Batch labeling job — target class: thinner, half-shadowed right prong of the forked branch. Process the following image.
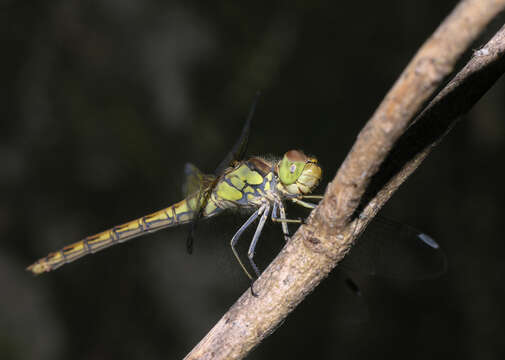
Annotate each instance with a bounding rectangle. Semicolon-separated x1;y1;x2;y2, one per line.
356;25;505;225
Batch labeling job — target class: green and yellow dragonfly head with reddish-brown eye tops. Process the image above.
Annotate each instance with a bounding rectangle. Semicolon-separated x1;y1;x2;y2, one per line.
277;150;322;194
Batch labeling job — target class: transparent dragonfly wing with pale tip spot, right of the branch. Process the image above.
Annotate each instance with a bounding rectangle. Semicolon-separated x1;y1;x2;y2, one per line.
342;217;447;280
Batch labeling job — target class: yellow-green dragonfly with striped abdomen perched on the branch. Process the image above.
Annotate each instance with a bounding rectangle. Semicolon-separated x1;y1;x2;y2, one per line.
27;94;439;294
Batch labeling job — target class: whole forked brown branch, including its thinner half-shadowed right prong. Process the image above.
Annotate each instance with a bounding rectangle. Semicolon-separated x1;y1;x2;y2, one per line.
186;0;505;359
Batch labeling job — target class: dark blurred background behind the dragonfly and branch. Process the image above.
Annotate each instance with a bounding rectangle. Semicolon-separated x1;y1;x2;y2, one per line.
0;0;505;360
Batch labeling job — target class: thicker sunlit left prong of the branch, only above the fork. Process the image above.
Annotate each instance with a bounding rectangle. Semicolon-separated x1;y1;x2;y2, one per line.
320;0;504;231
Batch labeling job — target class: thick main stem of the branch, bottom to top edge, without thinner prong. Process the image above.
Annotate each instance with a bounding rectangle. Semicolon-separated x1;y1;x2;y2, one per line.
186;0;505;359
